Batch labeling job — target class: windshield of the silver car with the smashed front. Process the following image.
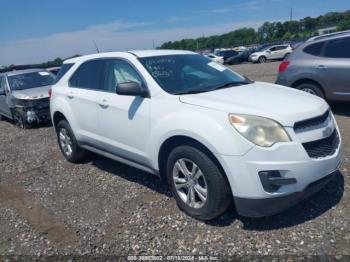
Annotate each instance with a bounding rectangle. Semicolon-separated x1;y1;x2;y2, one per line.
8;71;55;90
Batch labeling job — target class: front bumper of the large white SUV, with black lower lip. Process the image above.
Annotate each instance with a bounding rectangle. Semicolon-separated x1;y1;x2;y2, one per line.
220;129;342;217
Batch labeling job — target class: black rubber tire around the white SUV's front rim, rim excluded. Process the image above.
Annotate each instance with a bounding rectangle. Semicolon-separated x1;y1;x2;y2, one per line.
166;145;232;220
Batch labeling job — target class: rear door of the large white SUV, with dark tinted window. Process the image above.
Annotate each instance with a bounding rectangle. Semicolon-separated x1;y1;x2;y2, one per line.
67;60;104;146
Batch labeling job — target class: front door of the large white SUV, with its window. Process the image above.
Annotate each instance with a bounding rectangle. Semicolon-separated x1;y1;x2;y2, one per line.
98;58;151;165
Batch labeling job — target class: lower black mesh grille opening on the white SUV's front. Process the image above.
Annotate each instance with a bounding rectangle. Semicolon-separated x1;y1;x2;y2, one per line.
303;129;339;158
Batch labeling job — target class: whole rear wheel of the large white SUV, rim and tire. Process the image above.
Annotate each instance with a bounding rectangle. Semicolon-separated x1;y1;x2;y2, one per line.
56;120;86;163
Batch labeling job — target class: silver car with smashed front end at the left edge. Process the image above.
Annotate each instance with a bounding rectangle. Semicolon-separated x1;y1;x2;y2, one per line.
0;69;55;129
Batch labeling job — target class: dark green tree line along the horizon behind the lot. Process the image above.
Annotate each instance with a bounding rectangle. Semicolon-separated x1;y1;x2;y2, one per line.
159;10;350;51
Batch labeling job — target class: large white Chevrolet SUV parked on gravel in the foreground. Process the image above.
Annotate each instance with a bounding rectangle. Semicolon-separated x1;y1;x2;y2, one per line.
51;50;341;220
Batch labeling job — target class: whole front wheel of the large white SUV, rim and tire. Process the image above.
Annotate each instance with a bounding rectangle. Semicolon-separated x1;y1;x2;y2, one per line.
167;145;232;220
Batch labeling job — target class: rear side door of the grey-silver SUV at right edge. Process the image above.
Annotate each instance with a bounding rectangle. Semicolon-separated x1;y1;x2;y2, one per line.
315;37;350;98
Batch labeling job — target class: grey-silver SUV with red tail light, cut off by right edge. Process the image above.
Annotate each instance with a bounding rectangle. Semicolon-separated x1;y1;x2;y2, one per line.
276;31;350;101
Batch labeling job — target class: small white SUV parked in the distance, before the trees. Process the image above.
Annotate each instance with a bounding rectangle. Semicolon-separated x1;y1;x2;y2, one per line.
249;45;293;64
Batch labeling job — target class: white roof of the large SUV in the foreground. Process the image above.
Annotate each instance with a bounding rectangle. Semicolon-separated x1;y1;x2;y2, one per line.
64;49;198;64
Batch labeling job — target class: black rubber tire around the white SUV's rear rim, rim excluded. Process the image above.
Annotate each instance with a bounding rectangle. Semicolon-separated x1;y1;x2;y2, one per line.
56;120;86;163
